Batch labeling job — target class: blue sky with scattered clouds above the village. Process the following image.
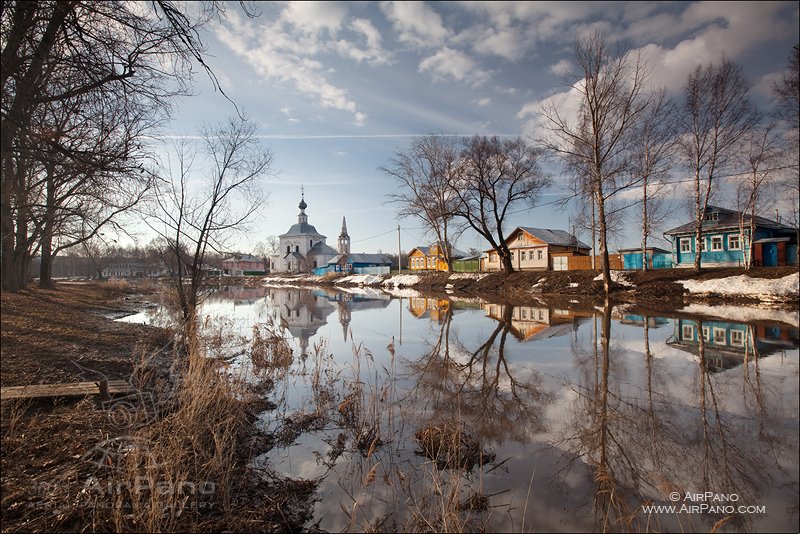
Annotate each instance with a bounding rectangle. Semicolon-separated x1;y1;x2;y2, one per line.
145;1;800;253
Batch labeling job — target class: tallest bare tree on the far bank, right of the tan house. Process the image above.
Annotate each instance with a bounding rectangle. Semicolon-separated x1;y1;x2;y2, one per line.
539;33;653;293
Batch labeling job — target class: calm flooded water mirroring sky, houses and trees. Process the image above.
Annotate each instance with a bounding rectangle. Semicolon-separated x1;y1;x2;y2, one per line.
119;288;800;532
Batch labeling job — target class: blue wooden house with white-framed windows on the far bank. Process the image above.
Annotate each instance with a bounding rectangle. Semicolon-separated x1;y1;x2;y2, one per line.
664;206;797;267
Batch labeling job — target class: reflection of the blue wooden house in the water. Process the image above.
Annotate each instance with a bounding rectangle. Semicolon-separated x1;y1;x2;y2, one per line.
667;319;798;373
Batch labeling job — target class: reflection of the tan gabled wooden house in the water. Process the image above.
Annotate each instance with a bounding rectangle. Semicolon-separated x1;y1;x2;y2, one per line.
483;304;592;341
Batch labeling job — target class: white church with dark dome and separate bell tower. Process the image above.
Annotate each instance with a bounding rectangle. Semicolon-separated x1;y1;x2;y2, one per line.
270;195;350;273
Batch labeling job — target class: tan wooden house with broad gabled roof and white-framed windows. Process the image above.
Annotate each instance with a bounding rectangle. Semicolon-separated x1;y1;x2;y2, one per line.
481;226;591;272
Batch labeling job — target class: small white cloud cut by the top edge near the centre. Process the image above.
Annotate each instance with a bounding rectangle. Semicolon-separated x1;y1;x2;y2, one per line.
381;2;450;46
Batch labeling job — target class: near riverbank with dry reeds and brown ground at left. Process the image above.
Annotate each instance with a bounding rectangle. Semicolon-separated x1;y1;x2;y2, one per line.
0;282;315;532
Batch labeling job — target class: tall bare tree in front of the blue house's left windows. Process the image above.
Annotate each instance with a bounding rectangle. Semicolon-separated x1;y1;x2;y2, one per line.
680;58;759;271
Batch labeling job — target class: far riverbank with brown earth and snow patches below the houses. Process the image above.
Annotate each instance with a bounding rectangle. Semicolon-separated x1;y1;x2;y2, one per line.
261;266;800;309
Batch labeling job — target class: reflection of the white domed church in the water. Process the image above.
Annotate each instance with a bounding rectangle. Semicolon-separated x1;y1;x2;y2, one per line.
267;288;391;357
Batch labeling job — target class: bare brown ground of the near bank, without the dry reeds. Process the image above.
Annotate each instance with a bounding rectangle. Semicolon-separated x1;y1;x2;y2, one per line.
0;283;315;532
